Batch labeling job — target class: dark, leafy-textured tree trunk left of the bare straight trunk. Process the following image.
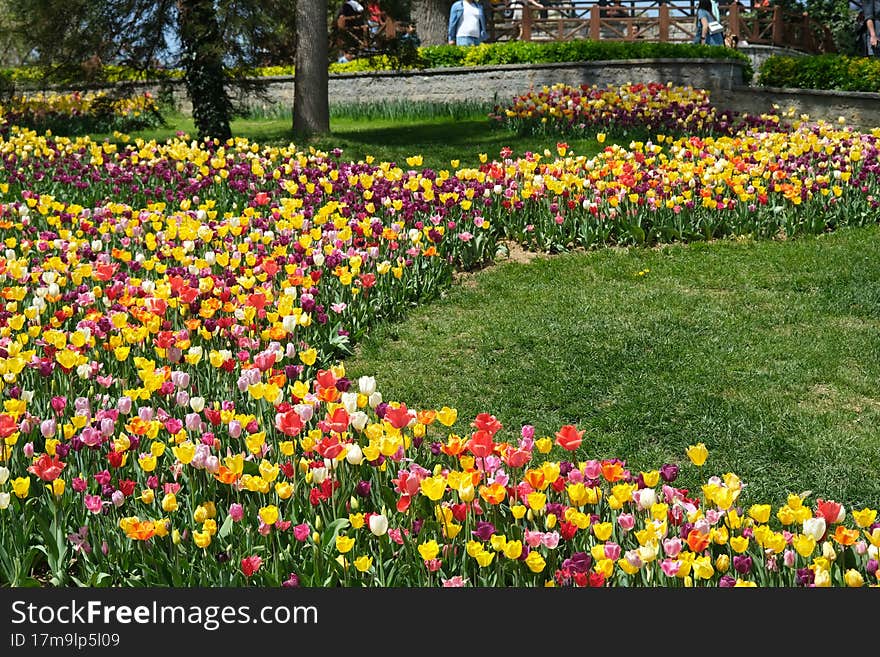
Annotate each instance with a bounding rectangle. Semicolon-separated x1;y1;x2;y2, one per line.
178;0;232;143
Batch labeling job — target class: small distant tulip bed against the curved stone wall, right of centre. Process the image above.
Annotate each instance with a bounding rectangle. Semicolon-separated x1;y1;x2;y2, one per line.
490;82;791;136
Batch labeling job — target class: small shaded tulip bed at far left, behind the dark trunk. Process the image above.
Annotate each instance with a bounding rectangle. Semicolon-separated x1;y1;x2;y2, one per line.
0;91;163;135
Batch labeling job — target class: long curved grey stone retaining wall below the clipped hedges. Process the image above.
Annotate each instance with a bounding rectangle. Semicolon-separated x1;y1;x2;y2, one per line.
44;57;880;130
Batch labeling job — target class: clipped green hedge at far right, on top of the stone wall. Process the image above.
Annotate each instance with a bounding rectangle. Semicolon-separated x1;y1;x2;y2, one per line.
758;55;880;92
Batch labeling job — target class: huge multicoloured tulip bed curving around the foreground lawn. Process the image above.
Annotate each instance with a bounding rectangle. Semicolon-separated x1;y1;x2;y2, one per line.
0;89;880;587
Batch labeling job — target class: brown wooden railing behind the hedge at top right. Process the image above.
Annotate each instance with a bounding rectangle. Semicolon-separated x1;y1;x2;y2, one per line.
490;0;835;53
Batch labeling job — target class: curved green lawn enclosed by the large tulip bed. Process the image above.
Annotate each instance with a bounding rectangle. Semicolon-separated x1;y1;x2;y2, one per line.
346;227;880;508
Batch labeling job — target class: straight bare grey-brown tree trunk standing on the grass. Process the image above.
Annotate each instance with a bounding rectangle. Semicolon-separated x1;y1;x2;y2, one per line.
293;0;330;135
